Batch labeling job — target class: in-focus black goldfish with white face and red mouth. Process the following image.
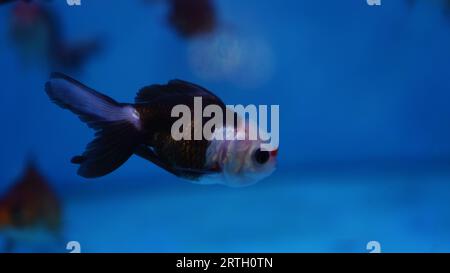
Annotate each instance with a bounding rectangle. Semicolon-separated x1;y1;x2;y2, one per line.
45;73;278;187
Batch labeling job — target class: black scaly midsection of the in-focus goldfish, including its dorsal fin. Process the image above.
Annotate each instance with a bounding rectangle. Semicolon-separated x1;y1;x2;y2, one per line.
134;80;226;178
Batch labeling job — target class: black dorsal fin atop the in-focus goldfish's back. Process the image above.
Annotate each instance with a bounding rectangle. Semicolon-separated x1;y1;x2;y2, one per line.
135;80;222;104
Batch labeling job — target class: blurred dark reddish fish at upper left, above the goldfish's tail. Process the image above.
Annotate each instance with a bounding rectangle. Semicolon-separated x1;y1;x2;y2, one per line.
10;1;101;72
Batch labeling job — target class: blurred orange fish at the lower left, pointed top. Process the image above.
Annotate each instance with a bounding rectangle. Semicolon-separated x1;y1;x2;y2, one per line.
0;161;62;252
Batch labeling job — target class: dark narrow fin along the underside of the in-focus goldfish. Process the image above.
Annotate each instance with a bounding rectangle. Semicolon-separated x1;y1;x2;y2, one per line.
134;145;219;179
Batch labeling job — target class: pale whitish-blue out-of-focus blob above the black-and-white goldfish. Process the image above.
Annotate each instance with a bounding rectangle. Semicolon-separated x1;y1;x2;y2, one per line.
187;28;275;90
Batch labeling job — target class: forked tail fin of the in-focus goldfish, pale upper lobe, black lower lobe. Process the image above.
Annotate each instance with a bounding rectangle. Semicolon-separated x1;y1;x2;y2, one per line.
45;73;141;178
